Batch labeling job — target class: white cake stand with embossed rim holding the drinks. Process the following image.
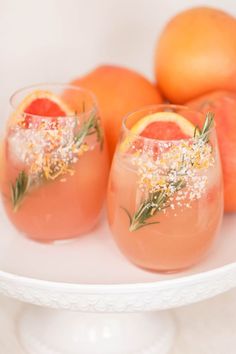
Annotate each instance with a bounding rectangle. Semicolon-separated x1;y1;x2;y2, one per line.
0;204;236;354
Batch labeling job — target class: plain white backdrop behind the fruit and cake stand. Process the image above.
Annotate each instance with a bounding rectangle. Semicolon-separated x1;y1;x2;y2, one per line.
0;0;236;354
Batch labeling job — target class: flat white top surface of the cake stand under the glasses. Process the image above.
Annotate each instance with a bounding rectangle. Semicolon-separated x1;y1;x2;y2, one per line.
0;199;236;284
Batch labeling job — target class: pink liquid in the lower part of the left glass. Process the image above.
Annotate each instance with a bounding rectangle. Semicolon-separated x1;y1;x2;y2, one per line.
1;137;108;242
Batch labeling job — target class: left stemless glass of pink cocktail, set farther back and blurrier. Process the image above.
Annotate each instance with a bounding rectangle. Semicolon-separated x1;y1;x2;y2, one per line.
1;84;108;242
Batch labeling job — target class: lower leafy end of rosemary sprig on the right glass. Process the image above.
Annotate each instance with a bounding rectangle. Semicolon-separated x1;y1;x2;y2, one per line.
122;179;185;232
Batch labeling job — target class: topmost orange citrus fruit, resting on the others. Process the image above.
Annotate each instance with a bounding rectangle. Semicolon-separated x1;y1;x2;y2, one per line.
155;7;236;103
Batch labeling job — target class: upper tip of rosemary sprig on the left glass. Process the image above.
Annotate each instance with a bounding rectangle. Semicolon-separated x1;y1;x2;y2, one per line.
75;114;103;150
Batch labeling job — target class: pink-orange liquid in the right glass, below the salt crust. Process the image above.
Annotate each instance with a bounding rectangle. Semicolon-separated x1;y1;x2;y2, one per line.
107;154;223;272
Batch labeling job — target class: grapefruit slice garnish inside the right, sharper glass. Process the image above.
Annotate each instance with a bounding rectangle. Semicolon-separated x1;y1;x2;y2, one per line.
121;112;195;152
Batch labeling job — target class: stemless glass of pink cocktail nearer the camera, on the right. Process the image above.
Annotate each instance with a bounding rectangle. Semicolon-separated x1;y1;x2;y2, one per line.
107;105;223;272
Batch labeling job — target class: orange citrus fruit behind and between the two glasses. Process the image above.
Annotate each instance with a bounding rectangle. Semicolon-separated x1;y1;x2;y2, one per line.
65;65;162;157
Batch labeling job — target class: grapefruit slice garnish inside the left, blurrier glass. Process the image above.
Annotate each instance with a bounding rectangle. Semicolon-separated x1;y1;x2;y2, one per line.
10;90;74;128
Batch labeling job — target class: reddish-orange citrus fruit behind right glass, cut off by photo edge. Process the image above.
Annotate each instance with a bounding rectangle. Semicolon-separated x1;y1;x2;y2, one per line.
188;91;236;211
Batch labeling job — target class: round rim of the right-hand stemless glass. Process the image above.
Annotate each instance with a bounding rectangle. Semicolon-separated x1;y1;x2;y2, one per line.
122;103;216;144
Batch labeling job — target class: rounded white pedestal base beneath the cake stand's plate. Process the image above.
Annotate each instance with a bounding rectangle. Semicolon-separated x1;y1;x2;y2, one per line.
20;307;175;354
